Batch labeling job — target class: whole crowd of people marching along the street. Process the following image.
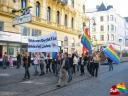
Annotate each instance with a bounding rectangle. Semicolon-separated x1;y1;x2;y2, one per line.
0;51;113;87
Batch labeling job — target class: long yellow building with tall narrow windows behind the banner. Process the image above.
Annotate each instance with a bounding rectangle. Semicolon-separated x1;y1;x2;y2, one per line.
0;0;86;58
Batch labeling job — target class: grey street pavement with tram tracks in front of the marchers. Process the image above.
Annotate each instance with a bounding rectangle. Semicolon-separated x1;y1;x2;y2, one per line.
0;62;128;96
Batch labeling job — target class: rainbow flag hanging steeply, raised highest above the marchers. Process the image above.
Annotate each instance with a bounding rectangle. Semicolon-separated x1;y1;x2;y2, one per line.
81;28;92;54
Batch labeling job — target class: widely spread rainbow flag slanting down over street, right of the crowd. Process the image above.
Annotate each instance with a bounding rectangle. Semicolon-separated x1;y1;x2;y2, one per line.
103;45;120;64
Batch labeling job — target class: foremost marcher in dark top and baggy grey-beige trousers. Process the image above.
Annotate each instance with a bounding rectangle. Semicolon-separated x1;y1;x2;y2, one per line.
57;53;69;87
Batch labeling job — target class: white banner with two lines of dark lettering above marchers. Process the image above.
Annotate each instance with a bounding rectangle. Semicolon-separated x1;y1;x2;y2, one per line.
28;32;58;52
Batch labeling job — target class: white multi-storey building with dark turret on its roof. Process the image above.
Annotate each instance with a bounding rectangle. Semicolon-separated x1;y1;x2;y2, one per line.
87;3;128;51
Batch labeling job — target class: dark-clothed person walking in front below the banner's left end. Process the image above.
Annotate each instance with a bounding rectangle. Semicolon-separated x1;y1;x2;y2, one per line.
23;53;31;80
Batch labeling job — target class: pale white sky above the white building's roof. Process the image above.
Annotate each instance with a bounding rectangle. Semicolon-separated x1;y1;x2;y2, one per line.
86;0;128;17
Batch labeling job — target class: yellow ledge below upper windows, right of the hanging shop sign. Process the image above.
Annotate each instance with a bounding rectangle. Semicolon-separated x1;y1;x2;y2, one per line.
31;16;80;35
